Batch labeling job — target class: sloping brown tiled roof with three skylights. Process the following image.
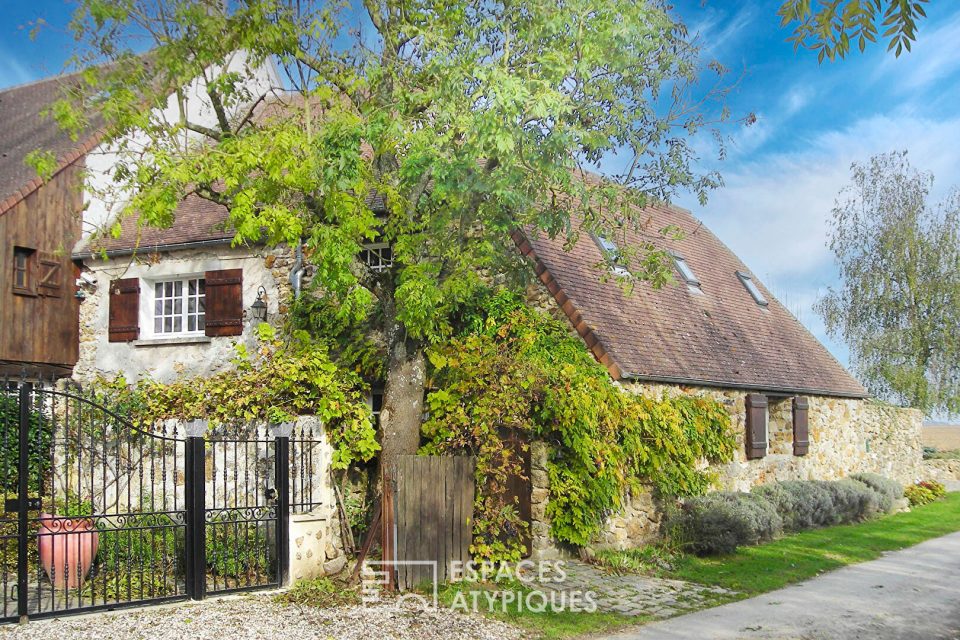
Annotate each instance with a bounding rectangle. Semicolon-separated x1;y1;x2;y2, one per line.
514;206;867;397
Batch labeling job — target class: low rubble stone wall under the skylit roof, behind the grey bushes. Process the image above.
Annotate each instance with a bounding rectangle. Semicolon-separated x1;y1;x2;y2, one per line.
532;383;928;557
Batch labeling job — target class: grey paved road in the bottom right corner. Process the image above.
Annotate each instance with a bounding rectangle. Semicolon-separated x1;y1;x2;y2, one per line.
614;533;960;640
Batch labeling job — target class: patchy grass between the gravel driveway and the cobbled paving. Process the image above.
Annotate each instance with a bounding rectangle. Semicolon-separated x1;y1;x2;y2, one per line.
440;583;650;640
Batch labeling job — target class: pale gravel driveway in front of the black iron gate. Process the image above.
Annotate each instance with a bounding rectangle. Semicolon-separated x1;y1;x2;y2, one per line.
0;594;523;640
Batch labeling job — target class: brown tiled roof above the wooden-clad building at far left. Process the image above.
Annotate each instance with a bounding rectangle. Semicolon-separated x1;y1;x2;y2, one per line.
0;75;96;214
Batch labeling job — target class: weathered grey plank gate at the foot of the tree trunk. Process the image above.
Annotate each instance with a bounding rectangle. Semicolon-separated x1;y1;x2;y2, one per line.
385;456;475;589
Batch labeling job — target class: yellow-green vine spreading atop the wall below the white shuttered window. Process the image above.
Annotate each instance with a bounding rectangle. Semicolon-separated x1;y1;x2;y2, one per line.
99;323;380;468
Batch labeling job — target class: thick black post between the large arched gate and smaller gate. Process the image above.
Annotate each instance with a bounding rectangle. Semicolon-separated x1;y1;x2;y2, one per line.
184;432;207;600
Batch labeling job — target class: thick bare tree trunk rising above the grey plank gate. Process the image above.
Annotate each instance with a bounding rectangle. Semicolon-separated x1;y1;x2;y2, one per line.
380;328;426;469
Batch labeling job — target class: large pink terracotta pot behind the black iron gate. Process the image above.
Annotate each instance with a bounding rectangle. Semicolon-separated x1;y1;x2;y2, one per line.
37;513;100;589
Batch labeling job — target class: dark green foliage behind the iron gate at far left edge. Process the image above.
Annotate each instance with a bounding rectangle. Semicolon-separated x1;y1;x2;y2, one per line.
0;393;53;494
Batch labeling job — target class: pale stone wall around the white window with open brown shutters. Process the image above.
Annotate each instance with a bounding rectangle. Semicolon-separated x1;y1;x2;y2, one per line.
74;245;293;382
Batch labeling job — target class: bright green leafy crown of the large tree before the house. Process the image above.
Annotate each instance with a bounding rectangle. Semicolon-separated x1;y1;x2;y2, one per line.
50;0;729;456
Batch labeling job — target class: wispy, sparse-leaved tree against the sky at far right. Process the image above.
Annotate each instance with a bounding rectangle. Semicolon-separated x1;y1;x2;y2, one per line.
817;152;960;414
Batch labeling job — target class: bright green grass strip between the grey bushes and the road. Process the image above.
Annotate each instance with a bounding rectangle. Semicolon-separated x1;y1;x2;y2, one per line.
663;493;960;598
